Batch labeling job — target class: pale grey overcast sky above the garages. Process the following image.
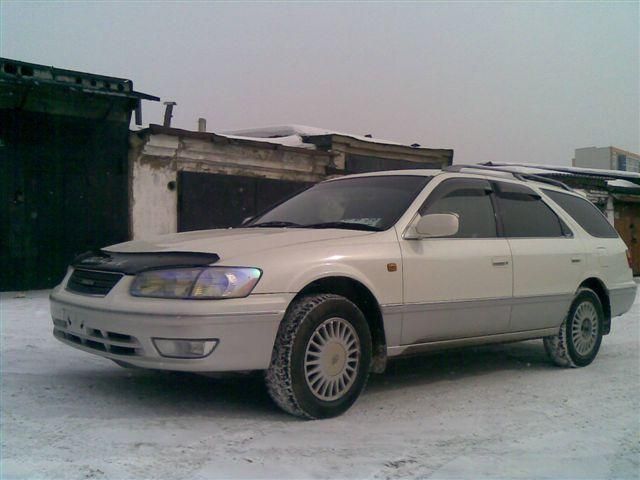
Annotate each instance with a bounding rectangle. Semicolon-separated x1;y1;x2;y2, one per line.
0;0;640;165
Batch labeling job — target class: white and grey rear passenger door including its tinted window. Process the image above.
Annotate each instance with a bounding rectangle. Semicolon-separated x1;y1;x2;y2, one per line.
493;182;585;332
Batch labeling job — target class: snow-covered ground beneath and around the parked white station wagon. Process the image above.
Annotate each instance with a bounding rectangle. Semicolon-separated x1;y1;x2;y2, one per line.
0;291;640;479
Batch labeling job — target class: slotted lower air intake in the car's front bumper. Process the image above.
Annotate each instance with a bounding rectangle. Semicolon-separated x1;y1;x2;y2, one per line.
53;318;143;356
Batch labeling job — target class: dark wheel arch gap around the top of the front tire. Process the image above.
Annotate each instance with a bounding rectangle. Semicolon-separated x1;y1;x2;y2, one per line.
294;276;387;373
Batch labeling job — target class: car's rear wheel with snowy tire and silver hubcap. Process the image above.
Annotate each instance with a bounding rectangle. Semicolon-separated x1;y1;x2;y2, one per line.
543;288;604;367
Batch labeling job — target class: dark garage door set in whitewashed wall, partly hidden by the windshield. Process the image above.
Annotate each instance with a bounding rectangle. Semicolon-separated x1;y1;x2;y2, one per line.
178;172;313;232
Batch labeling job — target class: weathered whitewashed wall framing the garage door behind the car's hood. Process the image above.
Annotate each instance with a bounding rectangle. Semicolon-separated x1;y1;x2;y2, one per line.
129;132;334;239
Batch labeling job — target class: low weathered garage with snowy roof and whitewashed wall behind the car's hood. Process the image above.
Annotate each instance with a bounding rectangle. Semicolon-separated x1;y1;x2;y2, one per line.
129;125;453;239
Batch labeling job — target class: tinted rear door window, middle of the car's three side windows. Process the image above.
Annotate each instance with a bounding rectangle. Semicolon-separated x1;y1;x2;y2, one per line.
496;183;570;238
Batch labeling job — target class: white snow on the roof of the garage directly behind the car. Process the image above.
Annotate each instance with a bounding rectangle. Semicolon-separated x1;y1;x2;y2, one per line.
220;125;426;149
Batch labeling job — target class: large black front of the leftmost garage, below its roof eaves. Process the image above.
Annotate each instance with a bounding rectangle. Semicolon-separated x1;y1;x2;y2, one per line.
0;110;129;290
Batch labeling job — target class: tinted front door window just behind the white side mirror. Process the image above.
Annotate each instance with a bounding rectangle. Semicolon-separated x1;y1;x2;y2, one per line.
420;179;497;238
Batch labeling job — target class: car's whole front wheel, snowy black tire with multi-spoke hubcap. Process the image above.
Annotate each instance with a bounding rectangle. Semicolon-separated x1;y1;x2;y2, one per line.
265;294;372;419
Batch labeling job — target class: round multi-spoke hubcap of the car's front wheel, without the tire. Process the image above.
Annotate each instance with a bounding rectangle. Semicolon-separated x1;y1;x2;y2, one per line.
304;317;360;401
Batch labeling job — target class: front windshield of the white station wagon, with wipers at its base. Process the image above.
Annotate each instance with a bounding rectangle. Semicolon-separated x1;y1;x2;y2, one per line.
247;175;431;231
